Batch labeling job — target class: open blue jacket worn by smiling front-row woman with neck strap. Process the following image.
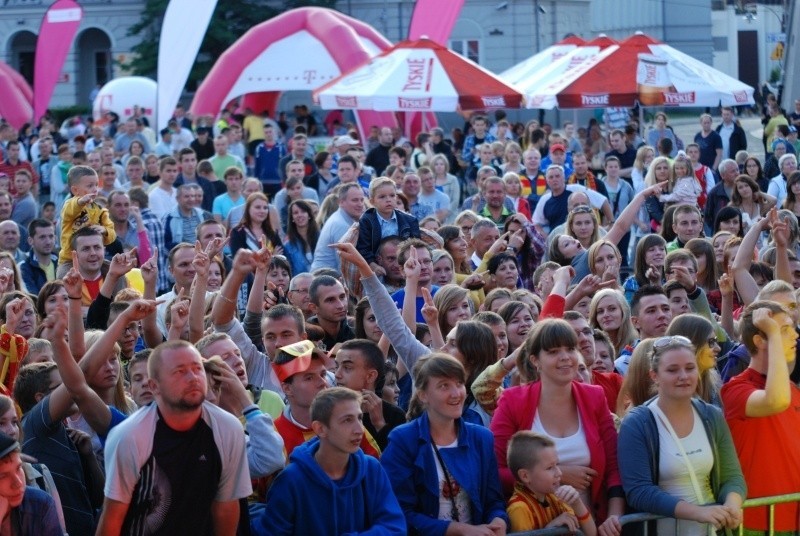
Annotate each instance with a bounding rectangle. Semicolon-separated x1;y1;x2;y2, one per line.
381;413;508;536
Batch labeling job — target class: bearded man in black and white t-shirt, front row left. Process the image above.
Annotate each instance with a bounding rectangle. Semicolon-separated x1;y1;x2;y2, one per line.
97;341;252;535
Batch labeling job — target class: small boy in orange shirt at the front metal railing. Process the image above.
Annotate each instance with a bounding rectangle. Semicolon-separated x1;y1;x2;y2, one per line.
506;430;597;536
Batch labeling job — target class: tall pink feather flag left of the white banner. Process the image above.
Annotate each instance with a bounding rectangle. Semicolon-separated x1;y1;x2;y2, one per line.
33;0;83;122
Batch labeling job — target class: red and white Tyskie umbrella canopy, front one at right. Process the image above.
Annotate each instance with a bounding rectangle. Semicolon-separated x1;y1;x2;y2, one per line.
525;33;754;109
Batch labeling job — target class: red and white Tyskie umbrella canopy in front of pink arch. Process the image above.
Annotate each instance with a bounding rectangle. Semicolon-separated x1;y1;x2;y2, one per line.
314;38;523;112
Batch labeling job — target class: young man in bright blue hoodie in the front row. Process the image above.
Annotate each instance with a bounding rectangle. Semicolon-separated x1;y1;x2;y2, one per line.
255;387;406;536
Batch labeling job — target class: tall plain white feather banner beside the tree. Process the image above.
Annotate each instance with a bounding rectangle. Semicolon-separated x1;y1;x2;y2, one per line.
156;0;217;132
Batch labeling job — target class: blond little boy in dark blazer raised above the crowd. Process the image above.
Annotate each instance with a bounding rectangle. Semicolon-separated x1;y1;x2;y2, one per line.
356;177;420;276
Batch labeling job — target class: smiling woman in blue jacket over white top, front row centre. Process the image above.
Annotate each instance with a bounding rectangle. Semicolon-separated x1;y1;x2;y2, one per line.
381;354;508;536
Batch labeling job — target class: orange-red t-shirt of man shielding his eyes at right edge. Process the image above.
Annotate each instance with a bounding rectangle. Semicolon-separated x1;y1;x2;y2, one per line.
721;368;800;531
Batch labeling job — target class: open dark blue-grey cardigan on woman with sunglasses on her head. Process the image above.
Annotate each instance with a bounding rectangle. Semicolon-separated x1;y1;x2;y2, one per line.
617;398;747;517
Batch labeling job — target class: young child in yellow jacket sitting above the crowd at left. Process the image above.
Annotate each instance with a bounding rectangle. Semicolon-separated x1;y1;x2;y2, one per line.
56;166;117;278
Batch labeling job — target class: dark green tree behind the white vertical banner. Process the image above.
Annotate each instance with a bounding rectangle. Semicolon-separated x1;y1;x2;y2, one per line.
122;0;336;91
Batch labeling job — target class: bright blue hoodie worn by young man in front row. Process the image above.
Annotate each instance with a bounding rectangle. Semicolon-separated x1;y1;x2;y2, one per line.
253;438;406;536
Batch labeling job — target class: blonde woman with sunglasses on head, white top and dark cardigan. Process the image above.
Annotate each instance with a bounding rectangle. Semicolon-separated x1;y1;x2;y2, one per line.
618;336;746;536
